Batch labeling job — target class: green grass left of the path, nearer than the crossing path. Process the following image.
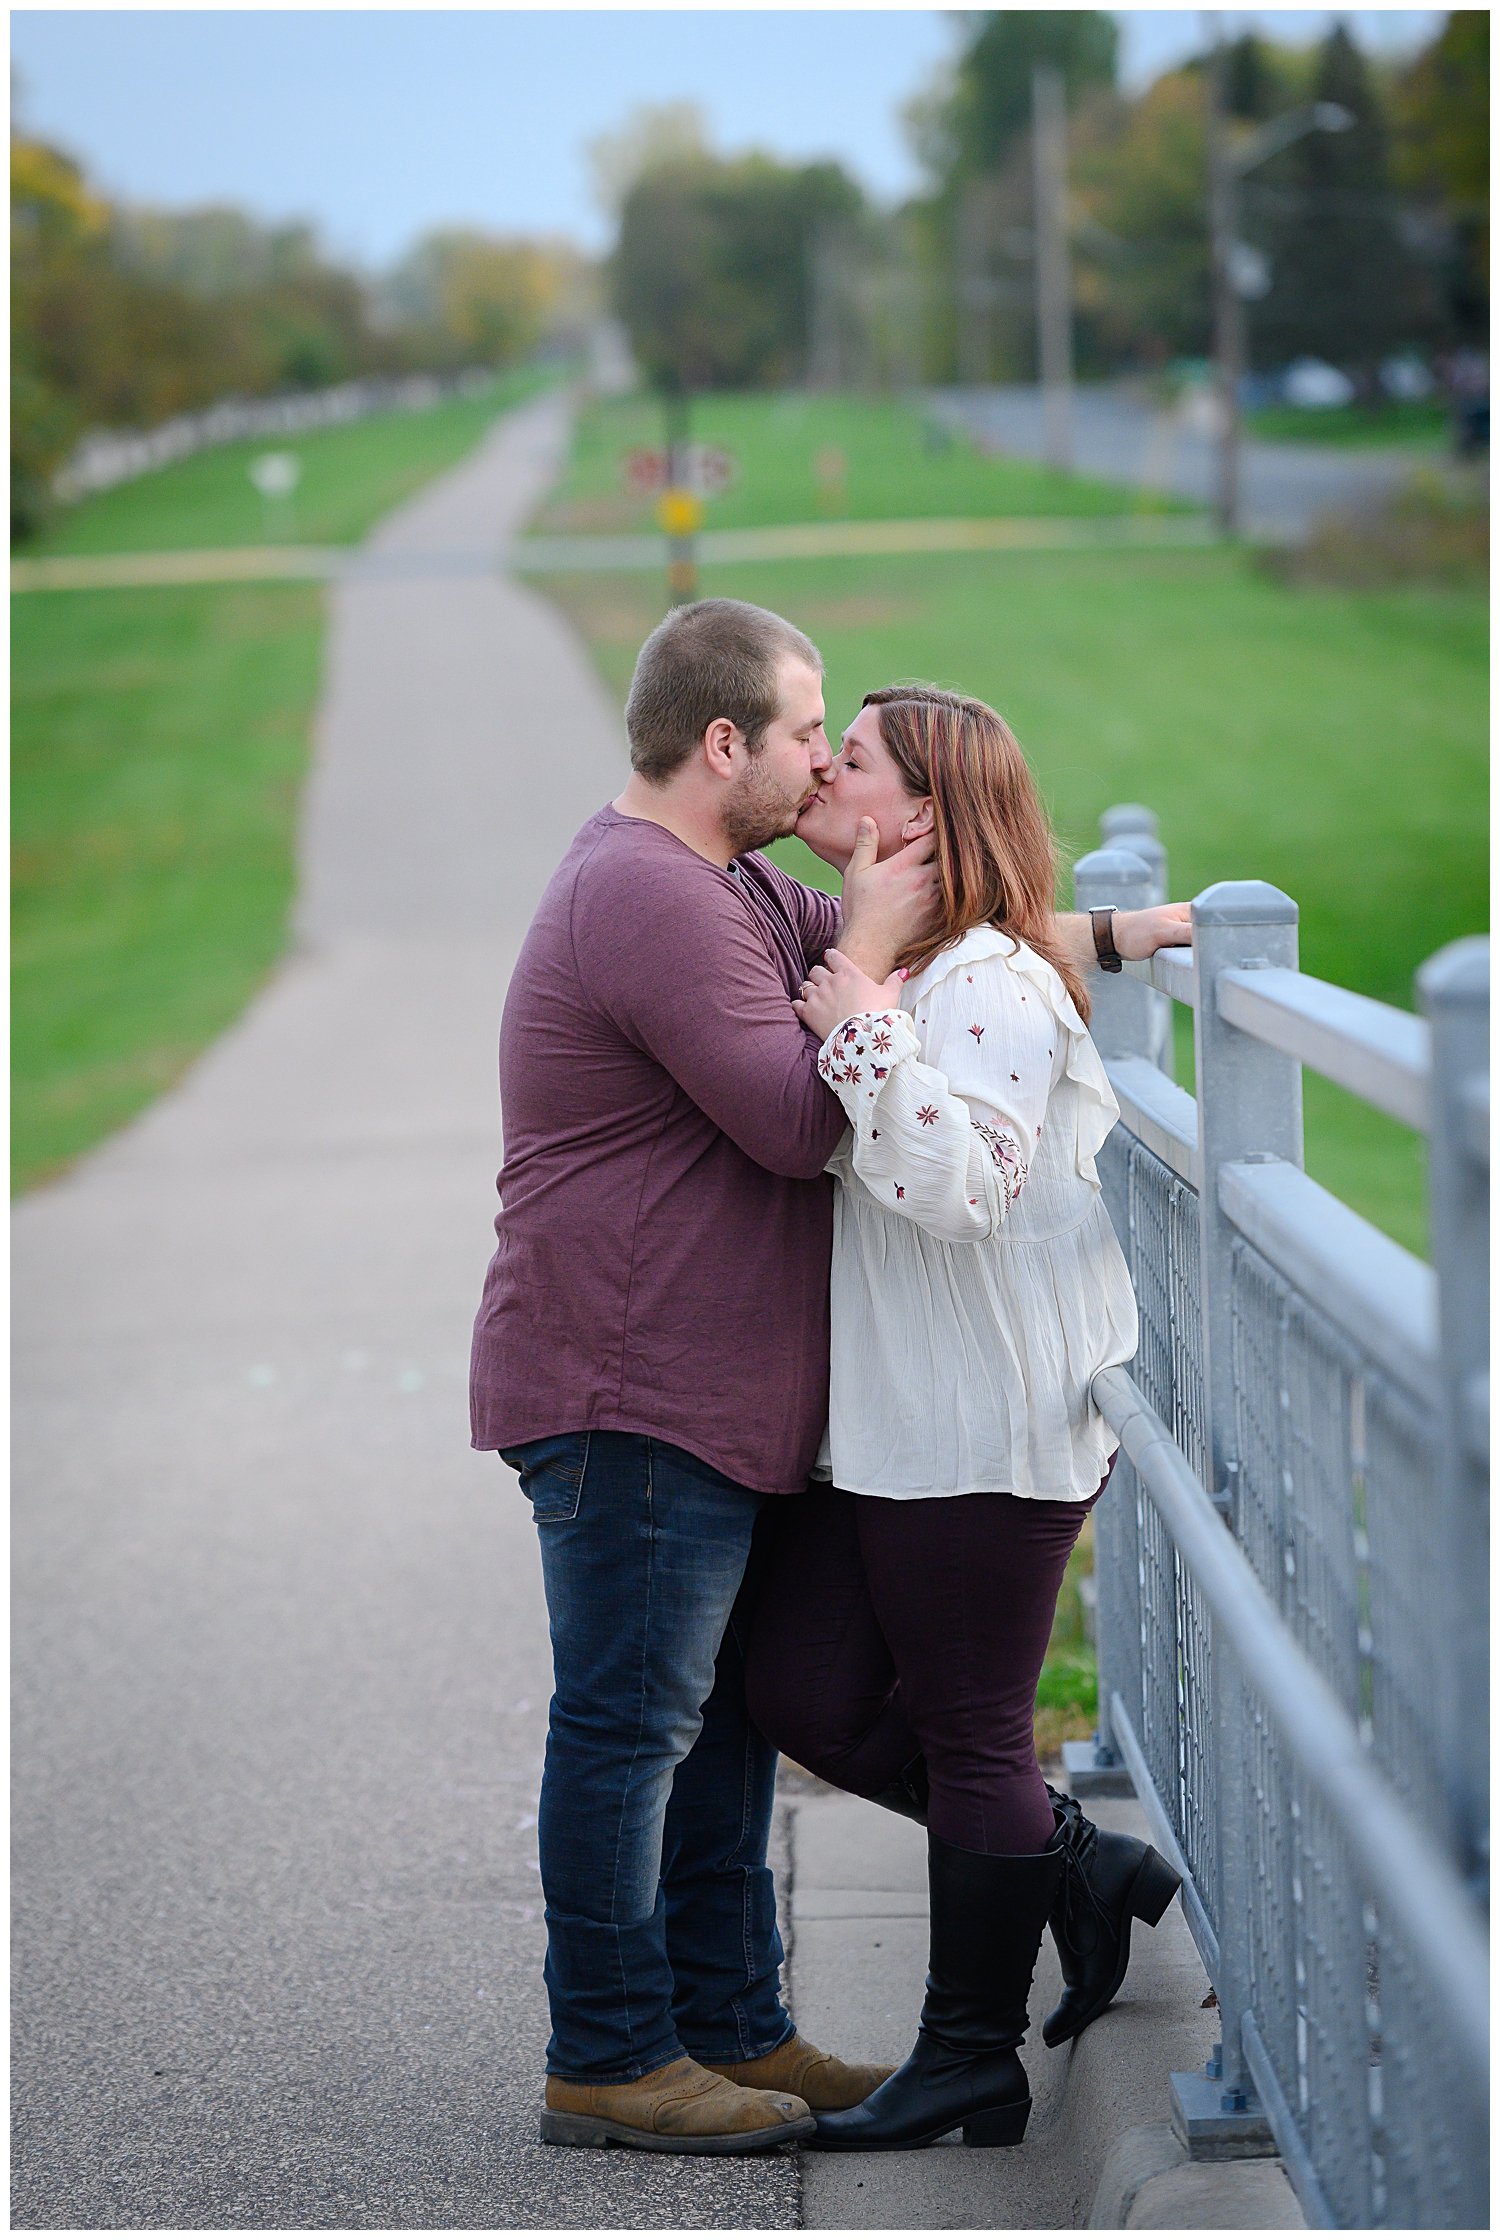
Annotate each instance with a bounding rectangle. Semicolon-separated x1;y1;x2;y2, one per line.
11;587;322;1189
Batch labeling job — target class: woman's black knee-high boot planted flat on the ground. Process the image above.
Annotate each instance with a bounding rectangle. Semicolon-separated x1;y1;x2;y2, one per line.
806;1830;1063;2150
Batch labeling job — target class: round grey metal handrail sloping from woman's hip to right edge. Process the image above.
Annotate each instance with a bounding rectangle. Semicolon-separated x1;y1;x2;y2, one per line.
1093;1369;1489;2074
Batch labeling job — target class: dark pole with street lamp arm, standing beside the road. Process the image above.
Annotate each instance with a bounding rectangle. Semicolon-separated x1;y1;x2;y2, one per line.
1209;16;1357;538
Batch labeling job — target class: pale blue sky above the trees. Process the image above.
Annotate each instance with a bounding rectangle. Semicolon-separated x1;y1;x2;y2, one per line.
11;7;1442;264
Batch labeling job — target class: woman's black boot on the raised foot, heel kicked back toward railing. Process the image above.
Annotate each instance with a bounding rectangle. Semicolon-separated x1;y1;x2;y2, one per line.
871;1756;1182;2045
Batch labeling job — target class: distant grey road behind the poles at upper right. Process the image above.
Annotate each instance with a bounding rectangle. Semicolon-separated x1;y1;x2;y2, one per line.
934;383;1422;542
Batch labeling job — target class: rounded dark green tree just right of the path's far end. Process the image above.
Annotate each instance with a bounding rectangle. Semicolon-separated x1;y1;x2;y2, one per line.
611;155;864;390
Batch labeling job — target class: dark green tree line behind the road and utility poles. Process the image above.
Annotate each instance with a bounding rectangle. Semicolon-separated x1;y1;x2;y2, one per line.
598;9;1489;396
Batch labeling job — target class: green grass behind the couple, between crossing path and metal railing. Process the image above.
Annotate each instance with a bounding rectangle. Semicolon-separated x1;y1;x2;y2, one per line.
544;533;1487;1250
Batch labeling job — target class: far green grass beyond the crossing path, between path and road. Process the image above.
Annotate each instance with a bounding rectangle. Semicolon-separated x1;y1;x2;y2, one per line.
533;392;1180;535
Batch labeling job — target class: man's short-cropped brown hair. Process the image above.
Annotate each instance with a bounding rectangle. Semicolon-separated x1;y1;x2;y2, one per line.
625;598;824;786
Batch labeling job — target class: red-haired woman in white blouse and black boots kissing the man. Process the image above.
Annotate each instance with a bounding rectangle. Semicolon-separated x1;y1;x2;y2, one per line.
748;685;1178;2148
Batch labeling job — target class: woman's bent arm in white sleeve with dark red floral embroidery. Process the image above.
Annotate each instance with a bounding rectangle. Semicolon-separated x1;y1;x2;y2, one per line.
797;952;1059;1243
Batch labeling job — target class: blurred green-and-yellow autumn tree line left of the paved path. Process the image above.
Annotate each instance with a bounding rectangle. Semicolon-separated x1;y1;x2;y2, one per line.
11;132;589;535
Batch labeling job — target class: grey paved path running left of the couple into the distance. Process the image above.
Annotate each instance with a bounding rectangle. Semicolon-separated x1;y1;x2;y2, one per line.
11;401;797;2229
